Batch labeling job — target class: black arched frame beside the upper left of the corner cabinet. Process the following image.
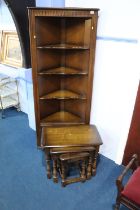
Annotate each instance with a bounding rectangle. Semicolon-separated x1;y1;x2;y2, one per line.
4;0;35;68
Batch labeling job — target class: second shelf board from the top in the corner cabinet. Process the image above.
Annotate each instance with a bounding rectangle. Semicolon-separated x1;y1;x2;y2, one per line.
38;66;88;75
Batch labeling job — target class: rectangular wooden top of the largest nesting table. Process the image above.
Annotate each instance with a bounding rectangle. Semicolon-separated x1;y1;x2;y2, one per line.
42;125;102;147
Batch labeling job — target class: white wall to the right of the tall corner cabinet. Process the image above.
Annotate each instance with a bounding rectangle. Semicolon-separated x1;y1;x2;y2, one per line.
65;0;140;164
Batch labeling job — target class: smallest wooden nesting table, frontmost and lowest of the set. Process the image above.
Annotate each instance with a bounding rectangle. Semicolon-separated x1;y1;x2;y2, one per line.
60;152;90;187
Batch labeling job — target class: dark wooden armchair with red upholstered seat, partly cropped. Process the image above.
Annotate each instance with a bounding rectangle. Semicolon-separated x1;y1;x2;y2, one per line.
115;154;140;210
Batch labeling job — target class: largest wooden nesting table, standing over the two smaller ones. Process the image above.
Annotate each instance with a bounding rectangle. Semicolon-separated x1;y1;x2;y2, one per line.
42;125;102;181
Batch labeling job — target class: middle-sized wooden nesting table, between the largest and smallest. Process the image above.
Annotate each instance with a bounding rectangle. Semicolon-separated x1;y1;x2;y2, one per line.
50;146;95;183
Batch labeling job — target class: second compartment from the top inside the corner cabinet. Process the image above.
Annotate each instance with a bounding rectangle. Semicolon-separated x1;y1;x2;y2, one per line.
37;49;90;74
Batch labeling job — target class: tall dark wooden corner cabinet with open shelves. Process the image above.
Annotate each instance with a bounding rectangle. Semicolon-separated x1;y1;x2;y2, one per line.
28;7;99;146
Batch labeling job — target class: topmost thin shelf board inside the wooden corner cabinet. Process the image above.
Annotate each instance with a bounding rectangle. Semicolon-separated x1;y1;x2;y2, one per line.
37;44;89;50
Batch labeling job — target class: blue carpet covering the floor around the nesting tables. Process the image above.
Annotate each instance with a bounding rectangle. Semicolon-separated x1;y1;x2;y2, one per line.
0;109;130;210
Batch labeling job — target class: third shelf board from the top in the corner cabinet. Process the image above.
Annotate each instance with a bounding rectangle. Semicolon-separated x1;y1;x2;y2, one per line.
40;90;86;100
